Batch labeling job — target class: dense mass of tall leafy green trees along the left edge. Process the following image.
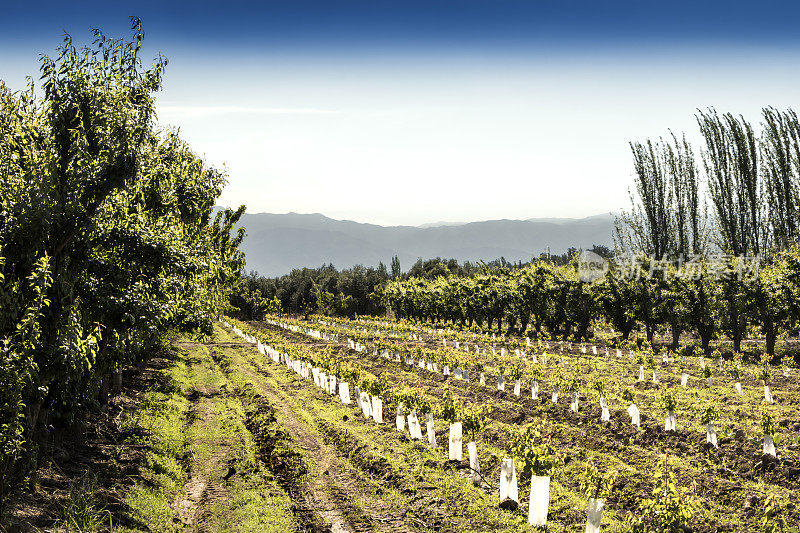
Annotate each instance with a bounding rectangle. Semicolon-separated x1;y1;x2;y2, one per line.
0;18;244;511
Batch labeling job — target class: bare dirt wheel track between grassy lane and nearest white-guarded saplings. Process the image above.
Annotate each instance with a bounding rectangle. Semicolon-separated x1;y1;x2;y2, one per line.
212;343;413;533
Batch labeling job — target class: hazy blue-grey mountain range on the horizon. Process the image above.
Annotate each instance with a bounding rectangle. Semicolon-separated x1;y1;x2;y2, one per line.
228;213;614;277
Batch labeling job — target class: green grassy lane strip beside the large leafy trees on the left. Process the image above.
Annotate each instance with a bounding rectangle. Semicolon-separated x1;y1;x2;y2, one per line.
119;330;304;532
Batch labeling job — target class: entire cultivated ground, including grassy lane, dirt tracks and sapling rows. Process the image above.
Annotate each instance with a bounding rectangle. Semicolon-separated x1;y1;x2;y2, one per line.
15;319;800;531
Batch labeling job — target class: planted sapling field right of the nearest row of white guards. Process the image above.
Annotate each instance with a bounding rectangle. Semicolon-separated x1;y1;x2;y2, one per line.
225;314;800;531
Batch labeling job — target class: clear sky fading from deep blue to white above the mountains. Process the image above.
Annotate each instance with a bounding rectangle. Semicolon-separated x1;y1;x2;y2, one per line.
0;0;800;225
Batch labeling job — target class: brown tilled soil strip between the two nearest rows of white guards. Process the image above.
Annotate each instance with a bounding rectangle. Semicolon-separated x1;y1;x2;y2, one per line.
253;323;800;531
